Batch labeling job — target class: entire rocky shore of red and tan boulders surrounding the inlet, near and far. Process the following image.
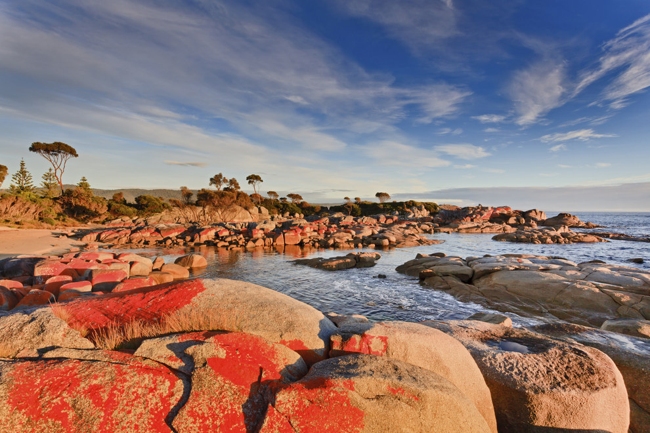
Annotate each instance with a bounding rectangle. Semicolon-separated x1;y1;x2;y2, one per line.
0;203;650;433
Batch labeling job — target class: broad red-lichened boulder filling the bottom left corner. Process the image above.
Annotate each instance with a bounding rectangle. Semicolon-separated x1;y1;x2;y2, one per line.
0;351;186;433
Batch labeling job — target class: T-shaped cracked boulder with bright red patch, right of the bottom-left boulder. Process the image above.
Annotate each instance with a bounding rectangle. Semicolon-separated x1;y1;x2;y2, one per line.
136;332;307;432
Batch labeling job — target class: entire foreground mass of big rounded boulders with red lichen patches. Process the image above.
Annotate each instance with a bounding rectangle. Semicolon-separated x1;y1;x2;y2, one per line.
0;279;636;433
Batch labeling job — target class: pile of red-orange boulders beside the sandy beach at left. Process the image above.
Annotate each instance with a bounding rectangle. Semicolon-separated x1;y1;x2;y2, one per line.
0;252;208;311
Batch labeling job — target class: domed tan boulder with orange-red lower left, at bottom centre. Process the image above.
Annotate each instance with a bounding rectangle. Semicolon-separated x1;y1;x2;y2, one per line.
261;355;491;433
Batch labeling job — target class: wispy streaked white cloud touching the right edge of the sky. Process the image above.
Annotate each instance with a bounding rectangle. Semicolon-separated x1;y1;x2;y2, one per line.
574;15;650;109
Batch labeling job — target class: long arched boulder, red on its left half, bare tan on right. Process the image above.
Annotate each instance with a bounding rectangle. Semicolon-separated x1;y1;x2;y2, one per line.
61;279;336;364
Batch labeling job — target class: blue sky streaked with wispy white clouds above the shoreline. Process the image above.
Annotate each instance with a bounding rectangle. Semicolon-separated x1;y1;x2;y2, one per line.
0;0;650;211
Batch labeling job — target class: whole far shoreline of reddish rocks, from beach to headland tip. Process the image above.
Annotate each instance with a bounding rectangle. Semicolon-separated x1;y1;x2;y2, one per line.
69;207;633;250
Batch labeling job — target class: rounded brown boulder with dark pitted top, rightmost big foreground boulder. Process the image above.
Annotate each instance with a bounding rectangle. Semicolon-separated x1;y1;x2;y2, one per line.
423;321;630;433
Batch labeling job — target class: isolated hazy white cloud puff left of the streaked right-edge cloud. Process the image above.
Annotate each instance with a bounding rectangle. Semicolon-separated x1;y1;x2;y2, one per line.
508;57;566;126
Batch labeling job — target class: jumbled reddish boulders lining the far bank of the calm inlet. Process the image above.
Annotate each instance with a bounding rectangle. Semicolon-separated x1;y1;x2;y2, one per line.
82;214;439;250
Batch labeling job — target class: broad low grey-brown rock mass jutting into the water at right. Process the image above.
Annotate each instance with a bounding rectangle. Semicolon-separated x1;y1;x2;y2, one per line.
396;253;650;327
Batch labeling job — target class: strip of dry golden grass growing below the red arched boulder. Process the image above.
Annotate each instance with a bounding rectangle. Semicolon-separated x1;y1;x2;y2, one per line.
88;311;225;350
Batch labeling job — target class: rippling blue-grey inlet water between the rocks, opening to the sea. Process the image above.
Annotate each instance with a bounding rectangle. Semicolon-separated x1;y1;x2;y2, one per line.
112;214;650;324
